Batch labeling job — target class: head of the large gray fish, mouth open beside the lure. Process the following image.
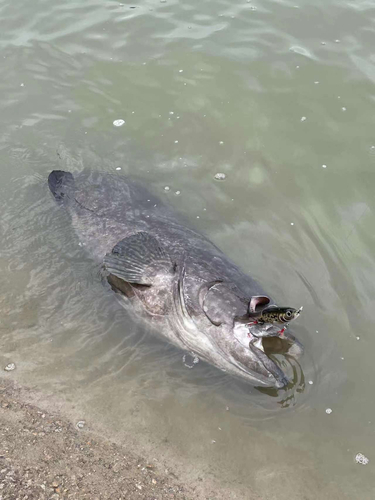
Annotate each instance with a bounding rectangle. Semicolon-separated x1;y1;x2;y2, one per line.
201;282;303;388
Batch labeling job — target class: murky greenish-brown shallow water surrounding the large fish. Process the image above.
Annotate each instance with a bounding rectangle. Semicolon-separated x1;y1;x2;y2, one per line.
0;0;375;500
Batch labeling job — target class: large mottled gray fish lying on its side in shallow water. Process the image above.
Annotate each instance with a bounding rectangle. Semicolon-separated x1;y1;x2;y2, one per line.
48;170;303;387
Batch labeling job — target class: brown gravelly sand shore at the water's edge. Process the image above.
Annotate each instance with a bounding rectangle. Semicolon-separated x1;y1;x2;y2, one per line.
0;379;206;500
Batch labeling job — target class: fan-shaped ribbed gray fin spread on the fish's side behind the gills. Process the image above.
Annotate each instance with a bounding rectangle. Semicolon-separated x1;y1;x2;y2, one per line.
104;232;173;286
